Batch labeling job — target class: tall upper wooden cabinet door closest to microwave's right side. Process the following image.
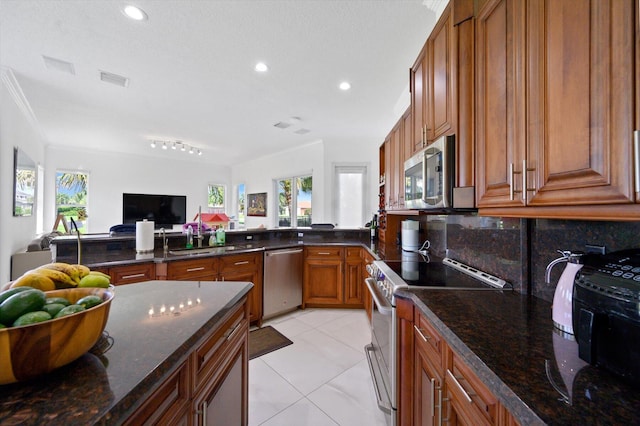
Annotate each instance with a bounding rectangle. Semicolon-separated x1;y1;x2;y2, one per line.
475;0;525;208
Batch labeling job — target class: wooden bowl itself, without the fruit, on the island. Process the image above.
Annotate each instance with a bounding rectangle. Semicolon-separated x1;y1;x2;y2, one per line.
0;288;114;385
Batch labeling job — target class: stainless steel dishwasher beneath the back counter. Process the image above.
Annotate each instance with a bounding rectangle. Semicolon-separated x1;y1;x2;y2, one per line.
263;248;304;319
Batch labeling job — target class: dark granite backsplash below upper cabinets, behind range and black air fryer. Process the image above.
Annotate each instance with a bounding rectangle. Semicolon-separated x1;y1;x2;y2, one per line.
402;213;640;302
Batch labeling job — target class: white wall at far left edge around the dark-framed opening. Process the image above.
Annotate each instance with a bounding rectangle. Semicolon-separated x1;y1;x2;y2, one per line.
0;69;44;286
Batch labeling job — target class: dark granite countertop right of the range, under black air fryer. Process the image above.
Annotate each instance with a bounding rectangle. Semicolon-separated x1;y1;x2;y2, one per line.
398;290;640;425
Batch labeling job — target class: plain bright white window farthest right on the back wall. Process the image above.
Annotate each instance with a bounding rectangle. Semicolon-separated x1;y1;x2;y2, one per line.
333;165;369;228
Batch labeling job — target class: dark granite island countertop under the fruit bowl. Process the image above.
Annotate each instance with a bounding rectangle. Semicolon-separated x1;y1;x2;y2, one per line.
0;281;253;425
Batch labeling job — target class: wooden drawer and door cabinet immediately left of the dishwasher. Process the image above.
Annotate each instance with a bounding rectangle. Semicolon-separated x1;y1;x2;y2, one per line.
219;252;263;322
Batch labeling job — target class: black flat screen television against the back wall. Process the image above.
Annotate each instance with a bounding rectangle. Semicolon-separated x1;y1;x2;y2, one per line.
122;193;187;228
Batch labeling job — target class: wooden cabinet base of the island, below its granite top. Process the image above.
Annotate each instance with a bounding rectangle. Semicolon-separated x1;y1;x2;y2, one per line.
124;299;249;426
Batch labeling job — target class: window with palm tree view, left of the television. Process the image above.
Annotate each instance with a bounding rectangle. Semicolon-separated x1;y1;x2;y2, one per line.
56;171;89;233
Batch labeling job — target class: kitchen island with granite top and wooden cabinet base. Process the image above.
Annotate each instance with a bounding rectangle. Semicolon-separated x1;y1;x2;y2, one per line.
0;281;253;425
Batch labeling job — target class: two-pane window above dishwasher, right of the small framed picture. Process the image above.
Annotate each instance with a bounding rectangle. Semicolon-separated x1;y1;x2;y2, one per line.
276;176;313;227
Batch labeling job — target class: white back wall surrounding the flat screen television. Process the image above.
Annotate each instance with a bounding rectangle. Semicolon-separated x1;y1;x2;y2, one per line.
44;147;231;233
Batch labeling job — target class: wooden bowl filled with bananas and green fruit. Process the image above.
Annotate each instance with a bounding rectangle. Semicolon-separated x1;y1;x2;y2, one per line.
0;264;114;385
